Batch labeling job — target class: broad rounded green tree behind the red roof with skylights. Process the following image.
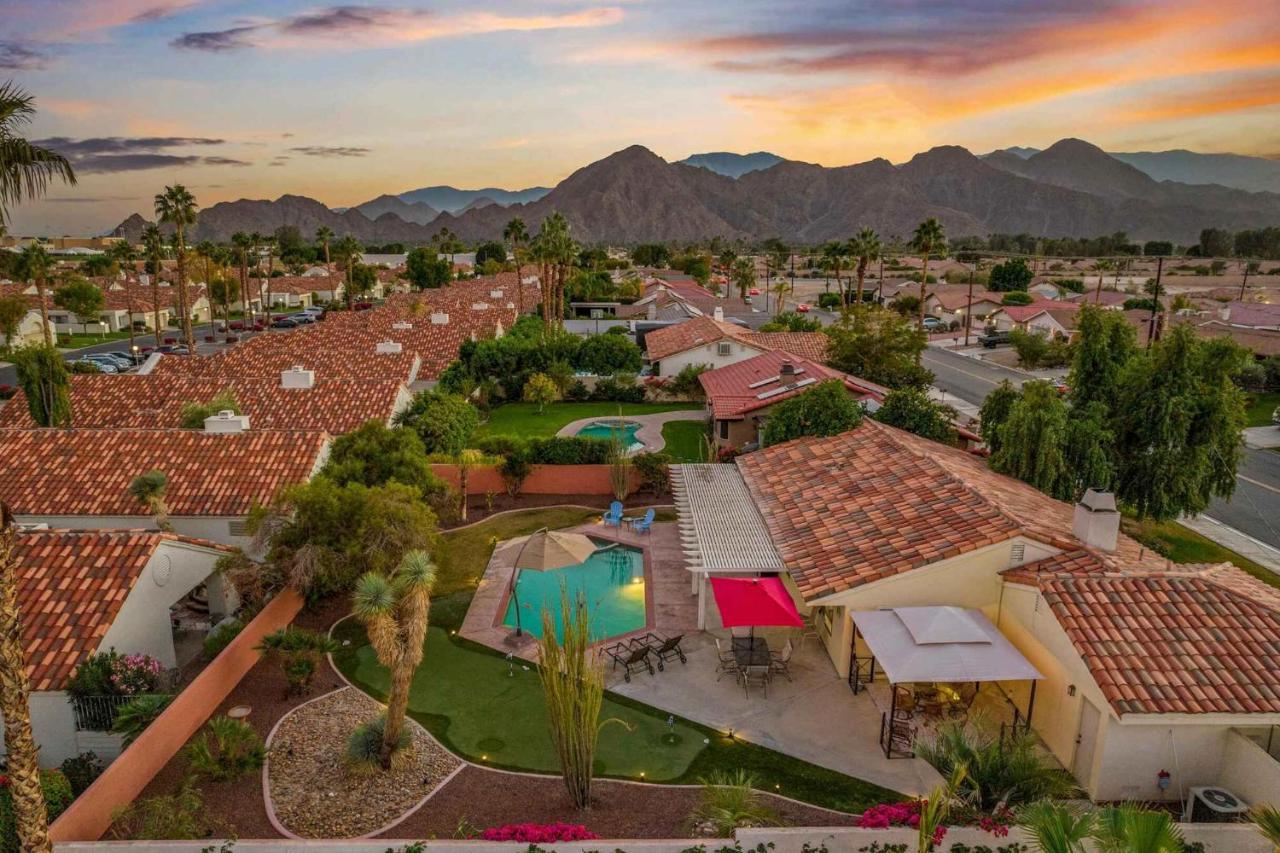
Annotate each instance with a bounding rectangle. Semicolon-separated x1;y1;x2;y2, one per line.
826;305;933;388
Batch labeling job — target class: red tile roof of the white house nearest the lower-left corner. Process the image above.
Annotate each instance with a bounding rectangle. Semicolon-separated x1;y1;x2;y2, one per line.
14;530;229;690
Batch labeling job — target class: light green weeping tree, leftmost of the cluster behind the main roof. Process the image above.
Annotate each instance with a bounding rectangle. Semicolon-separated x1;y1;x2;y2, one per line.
991;382;1074;501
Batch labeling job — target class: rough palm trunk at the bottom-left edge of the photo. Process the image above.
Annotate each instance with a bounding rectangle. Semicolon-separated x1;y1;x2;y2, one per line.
0;502;54;853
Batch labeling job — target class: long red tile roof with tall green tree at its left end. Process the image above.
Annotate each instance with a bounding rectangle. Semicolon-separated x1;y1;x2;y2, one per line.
0;373;407;435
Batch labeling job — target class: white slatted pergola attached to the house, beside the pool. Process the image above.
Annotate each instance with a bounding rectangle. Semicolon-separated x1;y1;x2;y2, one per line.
671;465;786;628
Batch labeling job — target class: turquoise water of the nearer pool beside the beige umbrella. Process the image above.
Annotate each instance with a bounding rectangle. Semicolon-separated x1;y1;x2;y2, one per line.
502;544;645;640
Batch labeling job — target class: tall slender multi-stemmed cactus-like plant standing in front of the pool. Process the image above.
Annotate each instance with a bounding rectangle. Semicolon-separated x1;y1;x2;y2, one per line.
538;589;604;808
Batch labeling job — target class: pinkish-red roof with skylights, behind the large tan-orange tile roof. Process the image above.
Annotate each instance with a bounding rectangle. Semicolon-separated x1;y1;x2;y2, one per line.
698;351;887;420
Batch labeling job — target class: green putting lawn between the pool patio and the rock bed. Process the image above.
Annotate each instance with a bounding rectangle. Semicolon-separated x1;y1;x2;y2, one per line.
334;617;904;812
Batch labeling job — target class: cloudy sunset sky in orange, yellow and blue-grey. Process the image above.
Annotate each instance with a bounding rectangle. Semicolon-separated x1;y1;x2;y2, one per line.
0;0;1280;234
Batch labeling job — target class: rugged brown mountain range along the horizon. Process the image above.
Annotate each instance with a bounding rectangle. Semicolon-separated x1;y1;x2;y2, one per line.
110;140;1280;243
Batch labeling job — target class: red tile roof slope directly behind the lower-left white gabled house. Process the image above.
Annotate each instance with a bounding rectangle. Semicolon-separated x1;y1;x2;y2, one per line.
0;429;329;516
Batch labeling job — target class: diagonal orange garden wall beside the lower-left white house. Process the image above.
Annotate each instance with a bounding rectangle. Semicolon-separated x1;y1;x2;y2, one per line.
50;589;303;841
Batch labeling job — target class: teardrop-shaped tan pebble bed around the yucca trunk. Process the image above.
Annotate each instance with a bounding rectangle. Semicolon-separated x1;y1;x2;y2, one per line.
265;688;461;838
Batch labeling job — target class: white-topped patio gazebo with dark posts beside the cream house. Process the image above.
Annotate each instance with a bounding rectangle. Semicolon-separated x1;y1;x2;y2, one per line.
850;607;1044;757
